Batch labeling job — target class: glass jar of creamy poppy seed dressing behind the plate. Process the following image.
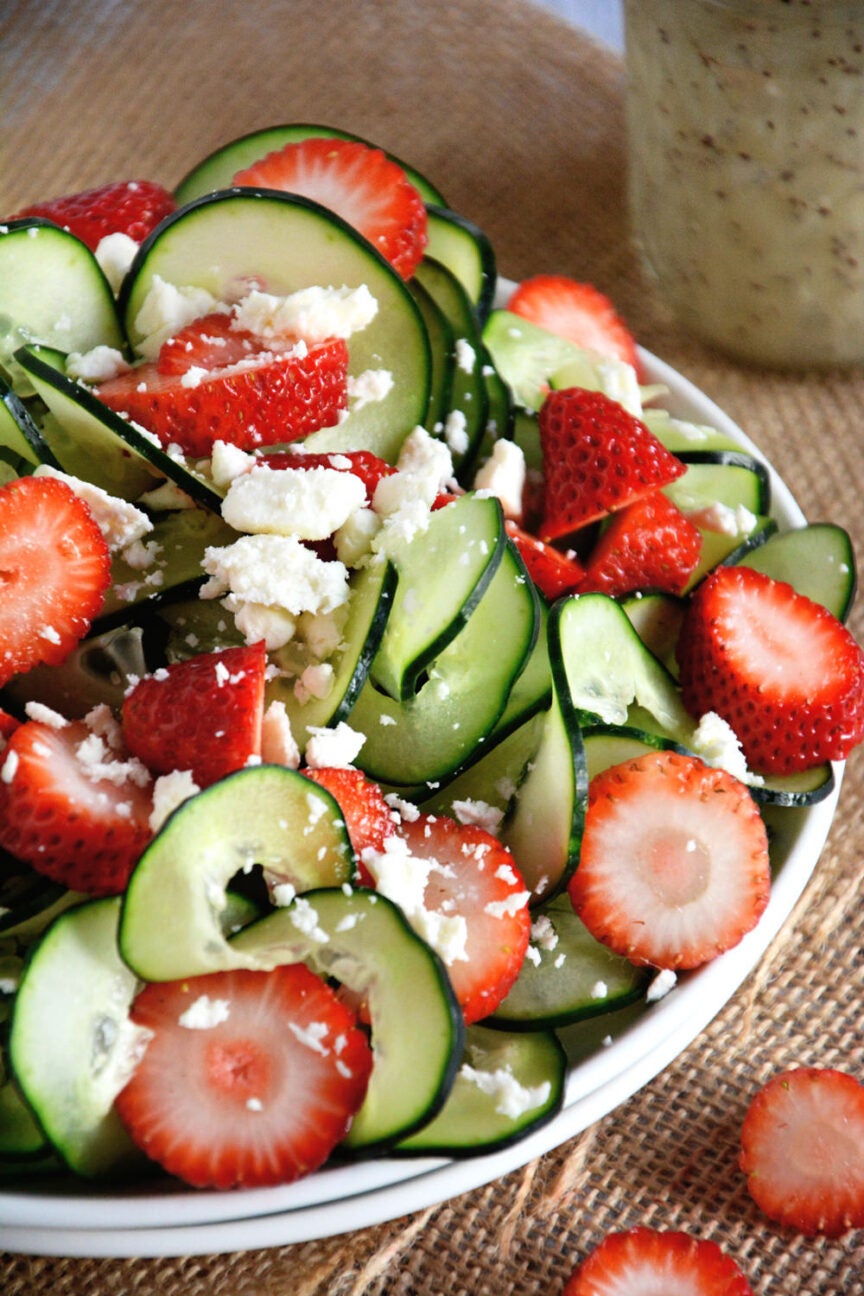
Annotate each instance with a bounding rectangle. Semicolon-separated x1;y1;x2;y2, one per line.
624;0;864;368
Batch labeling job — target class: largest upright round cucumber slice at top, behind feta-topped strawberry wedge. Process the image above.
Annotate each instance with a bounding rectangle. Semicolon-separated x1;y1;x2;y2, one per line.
118;189;431;461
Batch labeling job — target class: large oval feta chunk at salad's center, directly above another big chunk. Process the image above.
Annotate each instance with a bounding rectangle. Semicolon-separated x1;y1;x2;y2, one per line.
222;464;367;540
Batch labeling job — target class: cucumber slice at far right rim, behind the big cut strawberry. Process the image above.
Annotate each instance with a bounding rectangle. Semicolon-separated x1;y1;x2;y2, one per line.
738;522;858;621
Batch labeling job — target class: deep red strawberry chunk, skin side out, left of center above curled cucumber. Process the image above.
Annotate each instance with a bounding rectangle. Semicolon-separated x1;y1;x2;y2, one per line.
122;642;267;788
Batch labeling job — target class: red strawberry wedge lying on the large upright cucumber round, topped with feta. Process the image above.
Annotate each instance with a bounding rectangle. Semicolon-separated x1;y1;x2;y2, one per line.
96;325;348;459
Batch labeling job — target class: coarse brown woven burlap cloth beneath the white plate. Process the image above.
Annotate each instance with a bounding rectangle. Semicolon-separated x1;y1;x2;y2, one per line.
0;0;864;1296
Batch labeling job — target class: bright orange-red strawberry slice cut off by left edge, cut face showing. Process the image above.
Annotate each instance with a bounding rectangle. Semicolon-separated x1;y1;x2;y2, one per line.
0;477;111;684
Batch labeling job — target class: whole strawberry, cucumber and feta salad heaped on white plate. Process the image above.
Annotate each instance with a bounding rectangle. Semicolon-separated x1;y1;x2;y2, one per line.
0;124;864;1188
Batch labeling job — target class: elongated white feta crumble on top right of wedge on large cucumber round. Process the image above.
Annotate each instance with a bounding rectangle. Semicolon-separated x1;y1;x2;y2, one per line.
234;284;378;342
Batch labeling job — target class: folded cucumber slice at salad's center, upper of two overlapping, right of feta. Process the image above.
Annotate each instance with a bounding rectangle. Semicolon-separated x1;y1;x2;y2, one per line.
372;495;506;701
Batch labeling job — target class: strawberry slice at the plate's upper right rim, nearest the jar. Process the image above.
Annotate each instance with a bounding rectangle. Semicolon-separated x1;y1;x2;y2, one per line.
506;275;639;368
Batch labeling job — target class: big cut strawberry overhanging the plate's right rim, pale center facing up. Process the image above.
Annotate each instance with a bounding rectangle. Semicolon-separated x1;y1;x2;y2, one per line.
677;566;864;774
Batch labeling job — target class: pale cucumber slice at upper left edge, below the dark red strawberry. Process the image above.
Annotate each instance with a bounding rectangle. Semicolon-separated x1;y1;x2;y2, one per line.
0;219;124;389
